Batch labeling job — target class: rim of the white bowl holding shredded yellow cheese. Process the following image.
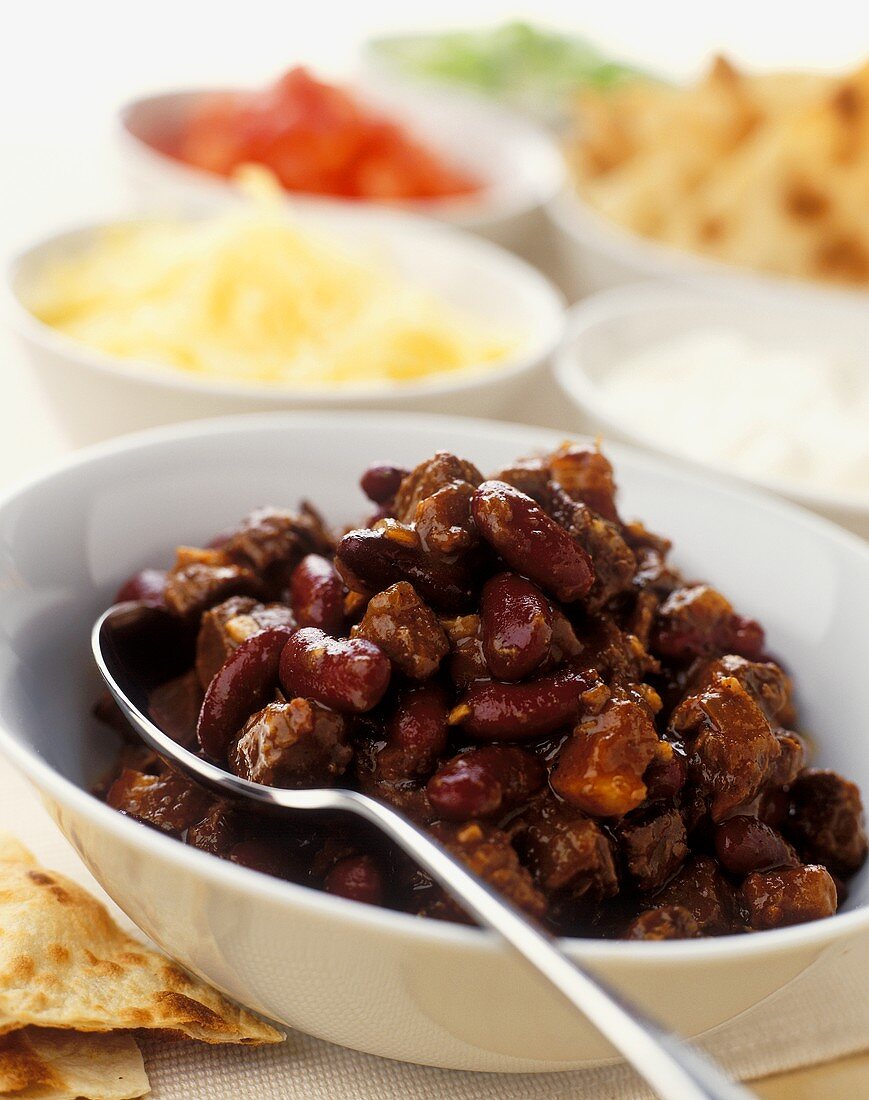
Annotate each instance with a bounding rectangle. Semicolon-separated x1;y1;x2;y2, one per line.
2;210;567;407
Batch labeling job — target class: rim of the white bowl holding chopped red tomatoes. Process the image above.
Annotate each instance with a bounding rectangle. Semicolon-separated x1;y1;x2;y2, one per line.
114;83;567;229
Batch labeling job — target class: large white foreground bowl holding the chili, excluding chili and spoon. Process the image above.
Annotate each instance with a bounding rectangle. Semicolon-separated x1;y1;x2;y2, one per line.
0;413;869;1071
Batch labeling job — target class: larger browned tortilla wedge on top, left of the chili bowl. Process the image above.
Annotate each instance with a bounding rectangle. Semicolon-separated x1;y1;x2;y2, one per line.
0;840;284;1044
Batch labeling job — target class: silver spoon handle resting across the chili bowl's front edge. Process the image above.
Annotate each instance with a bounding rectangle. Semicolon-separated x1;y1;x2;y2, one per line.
354;795;754;1100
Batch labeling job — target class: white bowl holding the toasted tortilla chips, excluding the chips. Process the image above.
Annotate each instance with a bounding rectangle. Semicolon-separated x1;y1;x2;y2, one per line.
546;186;869;311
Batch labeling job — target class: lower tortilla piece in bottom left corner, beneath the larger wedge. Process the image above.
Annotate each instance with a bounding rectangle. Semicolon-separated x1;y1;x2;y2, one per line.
0;1027;151;1100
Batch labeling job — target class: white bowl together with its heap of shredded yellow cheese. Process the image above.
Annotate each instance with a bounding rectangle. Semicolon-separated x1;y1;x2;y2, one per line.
10;188;563;442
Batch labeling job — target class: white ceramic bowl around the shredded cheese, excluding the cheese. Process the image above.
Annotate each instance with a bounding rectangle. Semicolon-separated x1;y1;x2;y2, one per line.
7;202;564;444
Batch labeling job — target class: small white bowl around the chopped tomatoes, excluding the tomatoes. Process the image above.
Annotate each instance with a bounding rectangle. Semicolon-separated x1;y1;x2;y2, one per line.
117;78;564;252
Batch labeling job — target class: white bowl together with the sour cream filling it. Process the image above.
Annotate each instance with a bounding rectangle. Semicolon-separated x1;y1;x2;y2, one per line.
556;283;869;537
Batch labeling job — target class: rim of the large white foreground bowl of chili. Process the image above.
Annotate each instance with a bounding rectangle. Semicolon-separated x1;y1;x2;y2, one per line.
0;410;869;966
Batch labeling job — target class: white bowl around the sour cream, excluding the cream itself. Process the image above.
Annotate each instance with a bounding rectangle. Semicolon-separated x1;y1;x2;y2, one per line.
554;282;869;538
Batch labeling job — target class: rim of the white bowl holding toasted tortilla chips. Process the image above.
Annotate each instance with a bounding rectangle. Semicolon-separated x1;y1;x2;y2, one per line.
546;180;869;312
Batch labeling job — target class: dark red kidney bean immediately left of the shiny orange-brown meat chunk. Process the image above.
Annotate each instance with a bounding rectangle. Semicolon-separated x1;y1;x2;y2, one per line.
426;745;546;822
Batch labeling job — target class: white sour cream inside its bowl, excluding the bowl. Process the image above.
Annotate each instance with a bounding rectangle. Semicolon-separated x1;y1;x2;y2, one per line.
598;329;869;499
